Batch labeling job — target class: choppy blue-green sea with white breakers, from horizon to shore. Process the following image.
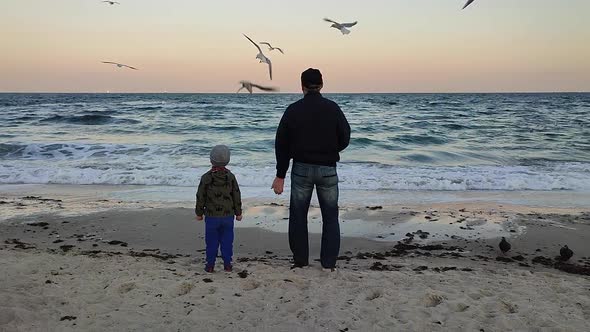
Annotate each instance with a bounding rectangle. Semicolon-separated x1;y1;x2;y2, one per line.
0;93;590;205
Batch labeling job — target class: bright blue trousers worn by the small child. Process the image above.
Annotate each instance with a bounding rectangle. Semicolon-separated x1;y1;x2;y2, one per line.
205;216;234;266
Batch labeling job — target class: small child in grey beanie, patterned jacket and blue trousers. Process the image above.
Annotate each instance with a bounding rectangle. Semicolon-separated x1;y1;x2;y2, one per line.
195;145;242;273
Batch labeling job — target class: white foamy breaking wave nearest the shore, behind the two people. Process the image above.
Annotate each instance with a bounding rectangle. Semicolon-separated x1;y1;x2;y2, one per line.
0;163;590;191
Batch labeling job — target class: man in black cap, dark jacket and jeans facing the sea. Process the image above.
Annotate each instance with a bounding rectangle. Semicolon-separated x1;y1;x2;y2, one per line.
272;68;350;271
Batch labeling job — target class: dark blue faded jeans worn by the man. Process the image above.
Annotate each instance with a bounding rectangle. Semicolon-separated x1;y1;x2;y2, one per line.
289;162;340;268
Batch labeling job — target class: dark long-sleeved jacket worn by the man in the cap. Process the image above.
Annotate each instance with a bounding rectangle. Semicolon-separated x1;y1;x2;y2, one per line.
275;92;350;178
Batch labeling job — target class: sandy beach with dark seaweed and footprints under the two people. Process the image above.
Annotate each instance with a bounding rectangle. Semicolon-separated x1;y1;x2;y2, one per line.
0;188;590;331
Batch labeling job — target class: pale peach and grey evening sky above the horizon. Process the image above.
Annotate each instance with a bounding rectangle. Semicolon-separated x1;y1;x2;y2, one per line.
0;0;590;93
